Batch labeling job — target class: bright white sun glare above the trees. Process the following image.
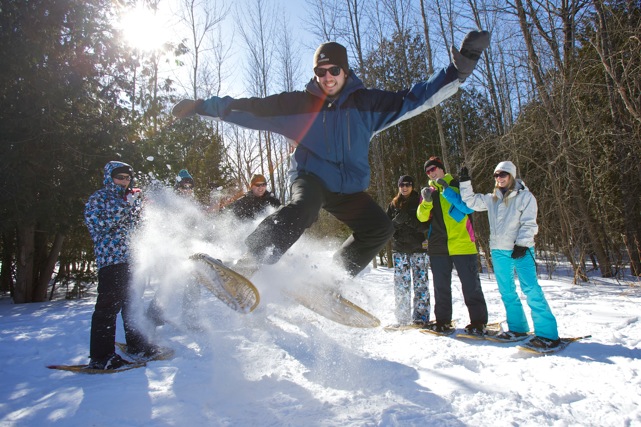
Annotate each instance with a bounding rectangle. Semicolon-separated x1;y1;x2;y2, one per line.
120;6;167;51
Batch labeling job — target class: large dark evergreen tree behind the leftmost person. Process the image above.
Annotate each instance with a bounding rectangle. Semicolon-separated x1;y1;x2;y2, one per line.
0;0;129;303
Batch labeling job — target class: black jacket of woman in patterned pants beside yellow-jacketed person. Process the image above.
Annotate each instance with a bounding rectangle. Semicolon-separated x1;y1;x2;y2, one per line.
387;190;429;254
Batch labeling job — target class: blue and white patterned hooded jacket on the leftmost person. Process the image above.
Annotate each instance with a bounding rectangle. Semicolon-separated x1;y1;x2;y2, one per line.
85;162;142;269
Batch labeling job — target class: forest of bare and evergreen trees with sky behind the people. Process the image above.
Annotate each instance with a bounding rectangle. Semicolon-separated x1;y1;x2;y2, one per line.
0;0;641;303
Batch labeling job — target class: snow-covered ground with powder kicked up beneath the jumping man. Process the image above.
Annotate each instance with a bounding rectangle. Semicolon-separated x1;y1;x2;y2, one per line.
0;191;641;427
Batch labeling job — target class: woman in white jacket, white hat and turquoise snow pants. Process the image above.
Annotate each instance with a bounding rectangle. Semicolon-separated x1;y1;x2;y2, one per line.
459;161;560;349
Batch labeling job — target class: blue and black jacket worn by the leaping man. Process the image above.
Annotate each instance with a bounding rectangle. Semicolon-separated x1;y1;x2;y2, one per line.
197;65;461;194
